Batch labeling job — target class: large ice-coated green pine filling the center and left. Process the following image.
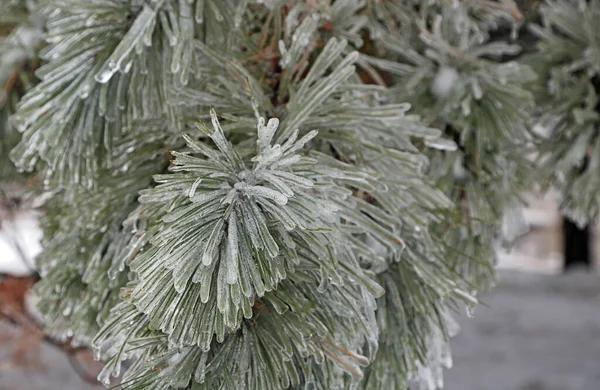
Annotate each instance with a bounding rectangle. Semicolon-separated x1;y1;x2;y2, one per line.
0;0;598;389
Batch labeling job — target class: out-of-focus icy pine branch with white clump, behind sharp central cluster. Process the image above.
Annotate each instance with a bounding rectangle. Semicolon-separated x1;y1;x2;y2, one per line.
358;1;536;285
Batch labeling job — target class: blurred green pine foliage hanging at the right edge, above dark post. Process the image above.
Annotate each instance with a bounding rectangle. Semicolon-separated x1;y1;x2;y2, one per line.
530;0;600;226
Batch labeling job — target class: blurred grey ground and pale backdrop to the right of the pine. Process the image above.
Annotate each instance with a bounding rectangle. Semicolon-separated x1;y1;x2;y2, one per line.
445;193;600;390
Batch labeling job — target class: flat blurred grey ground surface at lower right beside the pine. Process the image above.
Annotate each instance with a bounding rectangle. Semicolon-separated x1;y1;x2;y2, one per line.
444;272;600;390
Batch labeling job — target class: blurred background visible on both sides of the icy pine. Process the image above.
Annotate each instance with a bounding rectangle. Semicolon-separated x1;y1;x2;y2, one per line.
0;193;600;390
